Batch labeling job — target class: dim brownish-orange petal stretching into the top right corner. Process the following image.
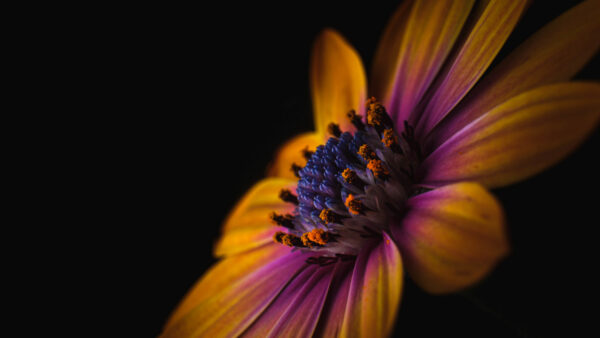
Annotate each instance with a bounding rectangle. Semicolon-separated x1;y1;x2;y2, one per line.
425;0;600;152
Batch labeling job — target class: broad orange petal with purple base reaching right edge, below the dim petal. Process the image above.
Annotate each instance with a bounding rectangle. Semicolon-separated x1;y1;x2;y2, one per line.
423;82;600;187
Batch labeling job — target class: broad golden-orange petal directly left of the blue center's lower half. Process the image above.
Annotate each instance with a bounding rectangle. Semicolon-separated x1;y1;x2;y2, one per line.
214;178;296;257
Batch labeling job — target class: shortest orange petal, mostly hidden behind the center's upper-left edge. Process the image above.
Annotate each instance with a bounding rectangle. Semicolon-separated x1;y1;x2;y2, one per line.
267;132;323;179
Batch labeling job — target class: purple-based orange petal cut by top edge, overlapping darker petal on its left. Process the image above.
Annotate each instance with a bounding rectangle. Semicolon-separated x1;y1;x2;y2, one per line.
388;0;474;128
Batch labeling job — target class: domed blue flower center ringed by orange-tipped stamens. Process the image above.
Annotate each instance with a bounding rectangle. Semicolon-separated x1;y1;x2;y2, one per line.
271;98;419;264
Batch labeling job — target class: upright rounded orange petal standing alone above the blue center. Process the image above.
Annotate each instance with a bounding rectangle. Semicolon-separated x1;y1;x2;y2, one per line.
310;29;367;140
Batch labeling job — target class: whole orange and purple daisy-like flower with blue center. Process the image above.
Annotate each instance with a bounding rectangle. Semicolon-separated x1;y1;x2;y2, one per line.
164;1;600;336
